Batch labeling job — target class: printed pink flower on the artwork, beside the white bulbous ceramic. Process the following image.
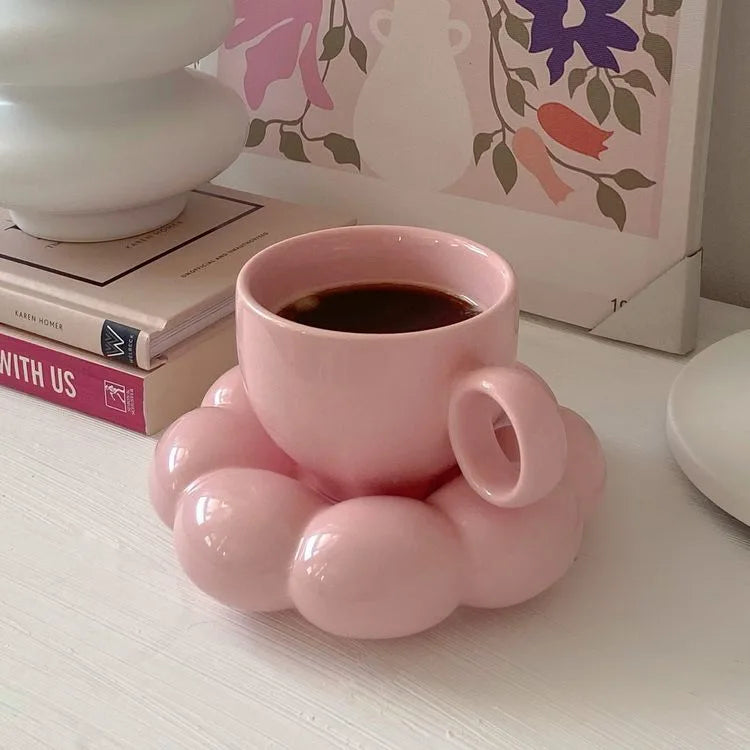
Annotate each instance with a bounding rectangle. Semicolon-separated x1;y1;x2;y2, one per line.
226;0;333;109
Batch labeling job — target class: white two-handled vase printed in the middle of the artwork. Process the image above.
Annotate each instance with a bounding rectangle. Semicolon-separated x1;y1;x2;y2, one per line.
354;0;474;192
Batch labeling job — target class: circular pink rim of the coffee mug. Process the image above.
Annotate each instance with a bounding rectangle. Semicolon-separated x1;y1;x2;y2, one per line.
235;224;518;341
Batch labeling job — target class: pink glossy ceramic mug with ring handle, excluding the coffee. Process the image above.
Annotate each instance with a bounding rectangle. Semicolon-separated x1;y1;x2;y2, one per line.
237;226;566;507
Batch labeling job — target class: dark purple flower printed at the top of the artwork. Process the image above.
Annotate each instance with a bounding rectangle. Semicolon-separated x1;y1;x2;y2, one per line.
518;0;638;83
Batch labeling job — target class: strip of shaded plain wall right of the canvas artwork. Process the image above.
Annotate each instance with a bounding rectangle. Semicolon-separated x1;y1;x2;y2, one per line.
703;0;750;307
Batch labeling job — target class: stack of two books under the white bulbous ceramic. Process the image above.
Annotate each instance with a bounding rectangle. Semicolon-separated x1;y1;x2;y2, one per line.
0;185;354;435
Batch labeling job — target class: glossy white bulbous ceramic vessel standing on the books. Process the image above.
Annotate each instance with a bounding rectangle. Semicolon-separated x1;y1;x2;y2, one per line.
0;0;249;242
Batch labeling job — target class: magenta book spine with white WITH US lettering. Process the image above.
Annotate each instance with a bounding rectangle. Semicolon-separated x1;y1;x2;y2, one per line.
0;333;146;432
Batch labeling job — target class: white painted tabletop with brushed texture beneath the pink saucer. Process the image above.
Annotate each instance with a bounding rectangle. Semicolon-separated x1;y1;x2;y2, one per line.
0;303;750;750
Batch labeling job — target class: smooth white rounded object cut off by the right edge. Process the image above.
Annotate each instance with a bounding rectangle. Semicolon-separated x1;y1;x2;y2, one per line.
667;331;750;525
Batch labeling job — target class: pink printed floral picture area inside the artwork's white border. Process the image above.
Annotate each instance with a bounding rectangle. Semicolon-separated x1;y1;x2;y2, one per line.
218;0;682;238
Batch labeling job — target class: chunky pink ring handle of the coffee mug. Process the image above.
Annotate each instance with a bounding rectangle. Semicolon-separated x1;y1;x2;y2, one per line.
448;365;568;508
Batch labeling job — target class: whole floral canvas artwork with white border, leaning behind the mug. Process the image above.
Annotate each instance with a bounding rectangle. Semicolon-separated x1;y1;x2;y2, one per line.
212;0;719;351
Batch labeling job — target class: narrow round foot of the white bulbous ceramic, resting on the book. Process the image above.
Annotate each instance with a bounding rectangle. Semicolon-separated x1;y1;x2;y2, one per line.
10;193;188;242
